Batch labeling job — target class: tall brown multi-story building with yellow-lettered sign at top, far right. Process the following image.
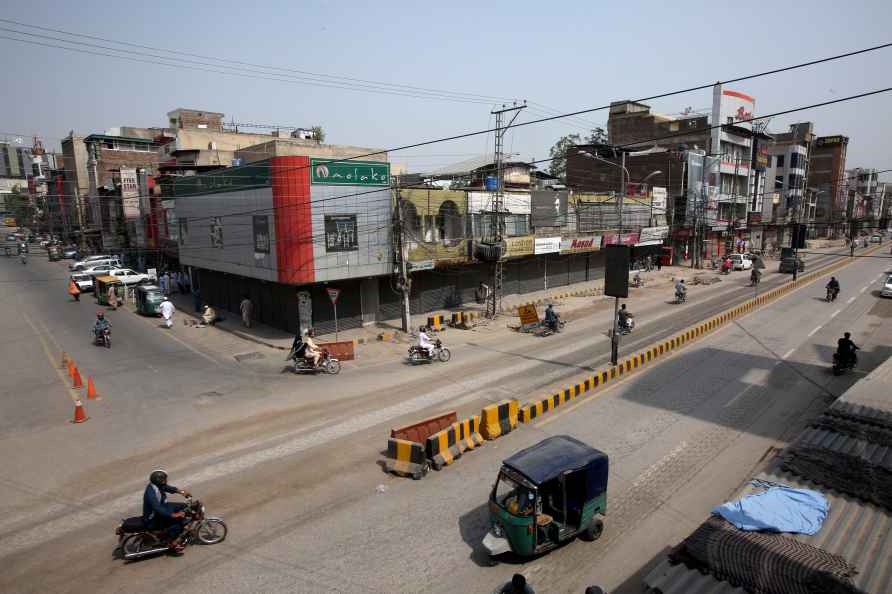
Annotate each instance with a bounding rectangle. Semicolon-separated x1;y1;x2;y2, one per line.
808;134;849;238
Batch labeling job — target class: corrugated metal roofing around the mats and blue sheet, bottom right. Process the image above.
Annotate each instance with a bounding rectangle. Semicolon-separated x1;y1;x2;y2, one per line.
644;352;892;594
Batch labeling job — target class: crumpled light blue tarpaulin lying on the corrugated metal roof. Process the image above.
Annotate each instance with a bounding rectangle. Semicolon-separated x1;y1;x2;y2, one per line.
712;478;830;534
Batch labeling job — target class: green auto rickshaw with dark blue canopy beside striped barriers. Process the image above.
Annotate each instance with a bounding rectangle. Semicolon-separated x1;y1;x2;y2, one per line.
483;435;608;562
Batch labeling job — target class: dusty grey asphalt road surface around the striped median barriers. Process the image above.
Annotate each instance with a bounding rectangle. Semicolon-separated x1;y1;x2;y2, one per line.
0;237;888;592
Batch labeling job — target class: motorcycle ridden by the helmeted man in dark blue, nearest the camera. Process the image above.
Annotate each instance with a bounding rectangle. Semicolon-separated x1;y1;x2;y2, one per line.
115;497;228;561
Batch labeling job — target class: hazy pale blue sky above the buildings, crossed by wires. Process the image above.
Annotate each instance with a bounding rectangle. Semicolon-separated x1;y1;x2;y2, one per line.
0;0;892;180
